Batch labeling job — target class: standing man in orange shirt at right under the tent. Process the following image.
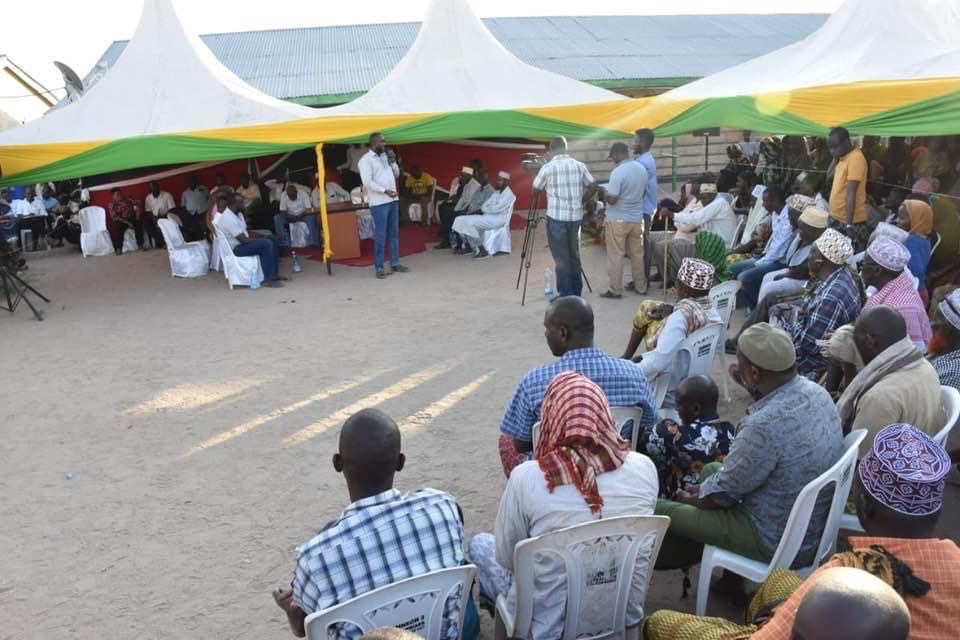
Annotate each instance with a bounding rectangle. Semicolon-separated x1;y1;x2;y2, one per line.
827;127;870;253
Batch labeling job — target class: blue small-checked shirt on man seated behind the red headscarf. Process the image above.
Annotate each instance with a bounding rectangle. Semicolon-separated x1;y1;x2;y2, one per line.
500;348;657;442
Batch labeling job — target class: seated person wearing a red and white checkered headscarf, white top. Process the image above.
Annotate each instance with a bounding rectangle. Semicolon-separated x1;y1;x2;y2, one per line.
470;371;659;640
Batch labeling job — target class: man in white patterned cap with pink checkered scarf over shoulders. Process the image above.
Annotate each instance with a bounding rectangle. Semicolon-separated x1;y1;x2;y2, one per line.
862;236;933;352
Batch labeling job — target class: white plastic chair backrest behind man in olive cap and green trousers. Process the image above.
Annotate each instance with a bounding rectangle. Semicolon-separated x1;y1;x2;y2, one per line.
770;429;867;571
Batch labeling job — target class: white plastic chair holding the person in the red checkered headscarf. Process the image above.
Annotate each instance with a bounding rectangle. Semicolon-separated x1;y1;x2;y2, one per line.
494;516;670;640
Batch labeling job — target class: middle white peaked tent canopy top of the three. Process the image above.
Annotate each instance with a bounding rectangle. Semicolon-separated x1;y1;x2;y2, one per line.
323;0;625;115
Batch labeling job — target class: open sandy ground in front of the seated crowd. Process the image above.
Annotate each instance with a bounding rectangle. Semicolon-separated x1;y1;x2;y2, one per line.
0;231;960;639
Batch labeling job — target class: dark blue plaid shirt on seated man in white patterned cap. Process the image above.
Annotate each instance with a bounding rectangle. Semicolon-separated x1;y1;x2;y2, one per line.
791;267;861;378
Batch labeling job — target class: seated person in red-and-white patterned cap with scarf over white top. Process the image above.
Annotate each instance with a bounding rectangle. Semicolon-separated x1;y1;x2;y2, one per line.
623;258;720;410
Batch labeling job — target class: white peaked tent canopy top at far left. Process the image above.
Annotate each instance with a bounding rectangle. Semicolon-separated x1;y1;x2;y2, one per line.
0;0;317;145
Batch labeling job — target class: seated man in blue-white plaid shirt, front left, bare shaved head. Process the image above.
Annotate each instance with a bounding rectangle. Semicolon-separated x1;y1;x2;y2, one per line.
273;409;464;640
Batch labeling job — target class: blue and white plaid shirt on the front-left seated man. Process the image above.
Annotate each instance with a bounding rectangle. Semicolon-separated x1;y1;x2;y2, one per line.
291;489;464;638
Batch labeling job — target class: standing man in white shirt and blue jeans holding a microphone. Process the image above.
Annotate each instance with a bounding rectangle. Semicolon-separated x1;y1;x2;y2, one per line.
358;131;410;280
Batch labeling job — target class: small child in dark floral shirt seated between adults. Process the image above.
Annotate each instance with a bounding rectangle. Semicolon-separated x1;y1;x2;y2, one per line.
637;376;736;500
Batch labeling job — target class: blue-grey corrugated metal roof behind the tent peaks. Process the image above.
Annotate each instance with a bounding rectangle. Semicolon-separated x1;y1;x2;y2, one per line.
88;14;827;102
